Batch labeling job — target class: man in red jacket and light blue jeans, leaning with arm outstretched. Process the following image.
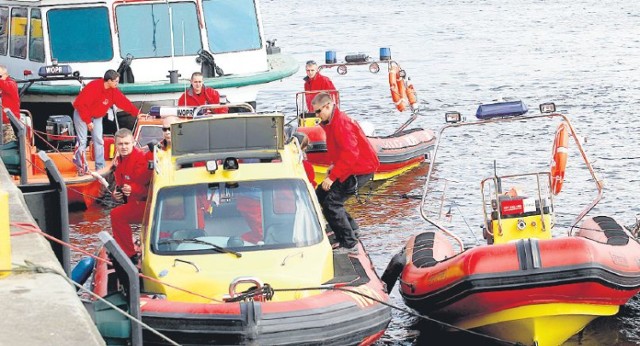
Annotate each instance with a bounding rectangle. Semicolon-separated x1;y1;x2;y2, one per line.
73;70;146;175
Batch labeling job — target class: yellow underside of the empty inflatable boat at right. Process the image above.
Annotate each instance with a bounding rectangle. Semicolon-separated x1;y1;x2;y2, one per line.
455;303;619;346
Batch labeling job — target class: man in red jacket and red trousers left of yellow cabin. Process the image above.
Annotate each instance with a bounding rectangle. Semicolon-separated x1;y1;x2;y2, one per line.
110;128;153;264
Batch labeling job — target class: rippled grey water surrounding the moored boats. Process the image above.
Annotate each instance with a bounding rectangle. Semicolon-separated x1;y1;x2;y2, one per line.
71;0;640;345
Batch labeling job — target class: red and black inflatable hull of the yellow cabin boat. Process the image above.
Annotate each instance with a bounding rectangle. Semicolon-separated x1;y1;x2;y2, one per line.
92;245;391;345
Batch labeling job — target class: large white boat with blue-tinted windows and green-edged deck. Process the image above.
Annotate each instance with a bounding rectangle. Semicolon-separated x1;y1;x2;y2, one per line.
0;0;298;127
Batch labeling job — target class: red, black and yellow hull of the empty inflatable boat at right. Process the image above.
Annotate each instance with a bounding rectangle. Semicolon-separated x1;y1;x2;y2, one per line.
392;221;640;345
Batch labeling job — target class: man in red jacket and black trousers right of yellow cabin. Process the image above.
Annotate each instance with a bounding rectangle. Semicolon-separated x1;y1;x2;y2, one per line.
312;93;380;254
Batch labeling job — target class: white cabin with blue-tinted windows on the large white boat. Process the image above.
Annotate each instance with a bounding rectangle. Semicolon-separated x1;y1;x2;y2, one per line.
0;0;269;92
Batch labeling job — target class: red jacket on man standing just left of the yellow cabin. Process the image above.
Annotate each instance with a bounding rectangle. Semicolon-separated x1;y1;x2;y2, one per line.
114;147;153;201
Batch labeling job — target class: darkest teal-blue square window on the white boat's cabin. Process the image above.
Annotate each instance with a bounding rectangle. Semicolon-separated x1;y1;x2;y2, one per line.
47;7;113;63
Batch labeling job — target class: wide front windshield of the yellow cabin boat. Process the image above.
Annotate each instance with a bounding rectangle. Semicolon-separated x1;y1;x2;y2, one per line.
151;179;322;255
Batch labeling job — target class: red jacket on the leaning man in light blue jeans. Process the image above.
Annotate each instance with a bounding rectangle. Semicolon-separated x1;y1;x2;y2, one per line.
73;78;140;124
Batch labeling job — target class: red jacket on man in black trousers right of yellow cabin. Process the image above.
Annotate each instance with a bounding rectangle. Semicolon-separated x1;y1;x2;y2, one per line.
321;106;380;182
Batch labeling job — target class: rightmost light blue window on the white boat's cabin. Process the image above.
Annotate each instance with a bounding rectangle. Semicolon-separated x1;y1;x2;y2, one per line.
202;0;262;53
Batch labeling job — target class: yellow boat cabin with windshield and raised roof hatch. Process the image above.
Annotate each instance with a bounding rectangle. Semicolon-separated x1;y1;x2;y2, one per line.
143;113;332;299
